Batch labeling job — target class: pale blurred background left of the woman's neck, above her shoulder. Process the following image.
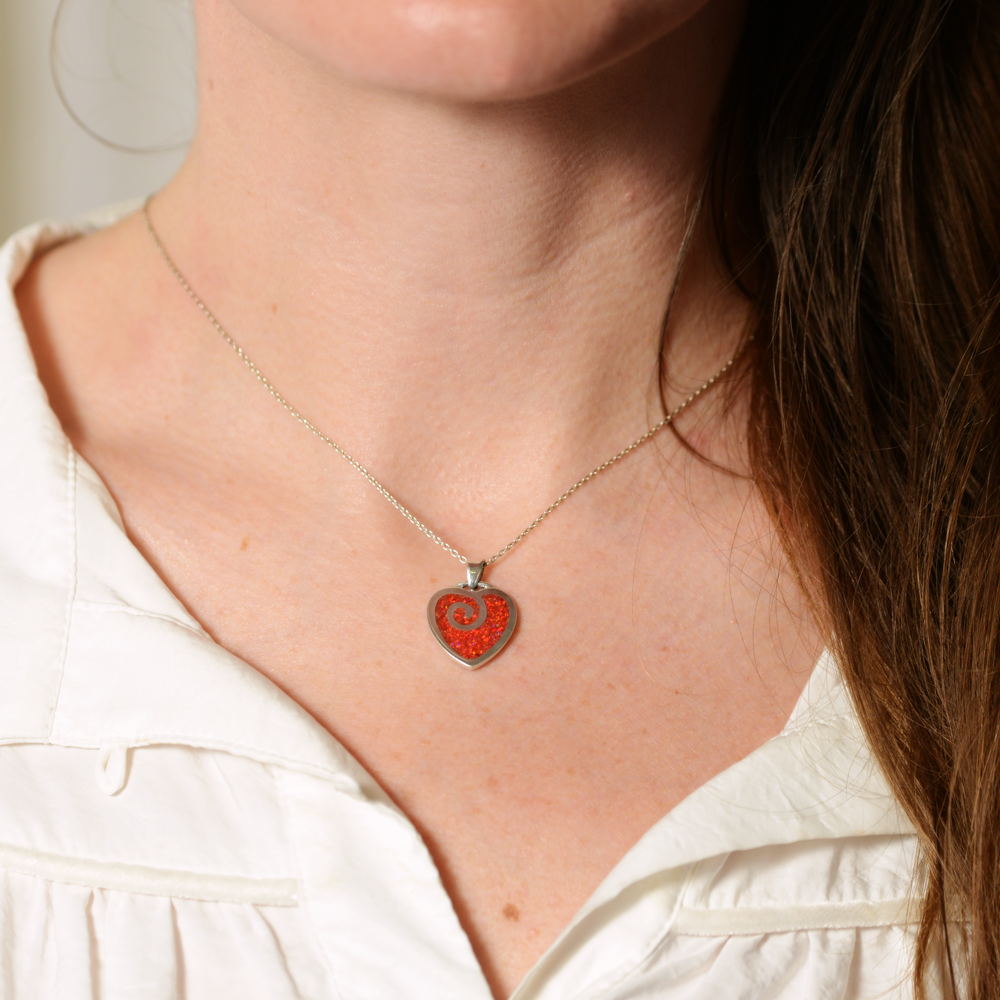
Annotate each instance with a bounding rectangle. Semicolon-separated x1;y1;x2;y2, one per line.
0;0;196;239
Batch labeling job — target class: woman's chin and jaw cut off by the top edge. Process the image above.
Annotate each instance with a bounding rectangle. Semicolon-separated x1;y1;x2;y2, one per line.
220;0;713;102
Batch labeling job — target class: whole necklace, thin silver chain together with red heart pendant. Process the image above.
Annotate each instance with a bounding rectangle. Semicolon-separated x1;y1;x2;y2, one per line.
142;198;752;670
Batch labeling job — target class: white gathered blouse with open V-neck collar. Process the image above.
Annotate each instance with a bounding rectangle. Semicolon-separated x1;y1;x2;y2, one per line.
0;216;917;1000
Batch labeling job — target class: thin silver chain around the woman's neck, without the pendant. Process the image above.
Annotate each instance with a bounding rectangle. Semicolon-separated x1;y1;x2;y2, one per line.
142;198;752;566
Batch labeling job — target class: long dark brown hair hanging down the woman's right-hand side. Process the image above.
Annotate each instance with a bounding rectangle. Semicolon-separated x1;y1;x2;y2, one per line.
713;0;1000;1000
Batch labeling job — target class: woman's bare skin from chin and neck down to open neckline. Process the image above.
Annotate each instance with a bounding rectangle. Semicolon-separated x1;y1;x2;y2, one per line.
18;0;821;997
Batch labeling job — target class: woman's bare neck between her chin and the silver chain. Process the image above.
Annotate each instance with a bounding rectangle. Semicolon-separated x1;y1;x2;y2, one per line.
152;0;743;532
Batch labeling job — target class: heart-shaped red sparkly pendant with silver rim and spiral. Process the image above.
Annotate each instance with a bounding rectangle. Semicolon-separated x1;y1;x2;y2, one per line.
427;562;517;670
